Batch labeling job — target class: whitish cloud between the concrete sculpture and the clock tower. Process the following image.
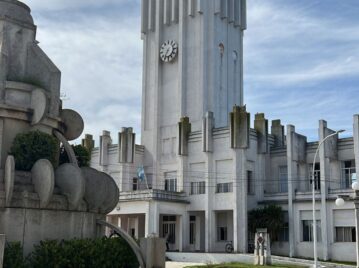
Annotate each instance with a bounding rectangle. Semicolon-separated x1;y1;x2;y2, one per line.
26;1;142;143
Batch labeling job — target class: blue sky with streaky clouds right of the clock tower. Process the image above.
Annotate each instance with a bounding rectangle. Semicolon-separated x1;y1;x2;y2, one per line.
244;0;359;140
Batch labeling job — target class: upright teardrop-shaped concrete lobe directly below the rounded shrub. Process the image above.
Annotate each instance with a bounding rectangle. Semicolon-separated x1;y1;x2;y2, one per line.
31;159;55;208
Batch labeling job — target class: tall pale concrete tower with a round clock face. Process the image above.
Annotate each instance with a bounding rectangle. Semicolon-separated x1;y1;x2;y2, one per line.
141;0;246;182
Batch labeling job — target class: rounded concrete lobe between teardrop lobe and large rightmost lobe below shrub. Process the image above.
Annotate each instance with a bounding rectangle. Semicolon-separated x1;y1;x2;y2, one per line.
55;164;85;209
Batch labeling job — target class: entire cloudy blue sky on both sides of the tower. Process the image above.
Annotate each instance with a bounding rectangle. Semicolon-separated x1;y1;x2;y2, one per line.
24;0;359;142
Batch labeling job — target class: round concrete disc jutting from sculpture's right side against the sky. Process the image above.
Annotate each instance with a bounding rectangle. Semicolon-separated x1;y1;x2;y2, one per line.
61;109;84;141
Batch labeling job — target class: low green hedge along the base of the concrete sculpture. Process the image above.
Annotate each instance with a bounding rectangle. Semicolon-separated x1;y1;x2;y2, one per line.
4;237;139;268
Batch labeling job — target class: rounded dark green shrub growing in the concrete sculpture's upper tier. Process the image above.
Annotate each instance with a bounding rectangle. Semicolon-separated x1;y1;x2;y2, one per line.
10;130;59;171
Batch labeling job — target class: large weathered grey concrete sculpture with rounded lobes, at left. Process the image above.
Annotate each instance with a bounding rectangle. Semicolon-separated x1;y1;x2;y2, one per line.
0;0;119;254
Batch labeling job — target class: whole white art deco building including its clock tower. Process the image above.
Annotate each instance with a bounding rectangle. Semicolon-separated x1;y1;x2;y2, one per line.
83;0;359;261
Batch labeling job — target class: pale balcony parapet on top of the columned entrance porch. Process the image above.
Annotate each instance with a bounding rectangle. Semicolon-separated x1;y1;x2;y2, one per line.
120;189;189;203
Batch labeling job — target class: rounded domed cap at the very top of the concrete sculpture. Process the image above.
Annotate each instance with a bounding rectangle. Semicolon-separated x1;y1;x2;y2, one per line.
0;0;34;25
